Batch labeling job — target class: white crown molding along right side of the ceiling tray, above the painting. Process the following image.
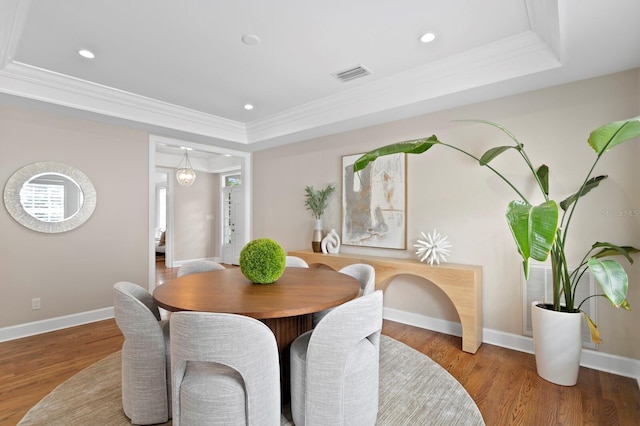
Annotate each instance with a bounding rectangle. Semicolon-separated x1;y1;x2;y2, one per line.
247;31;561;144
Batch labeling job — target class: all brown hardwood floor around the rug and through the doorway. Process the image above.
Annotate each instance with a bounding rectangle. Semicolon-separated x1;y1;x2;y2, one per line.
0;268;640;426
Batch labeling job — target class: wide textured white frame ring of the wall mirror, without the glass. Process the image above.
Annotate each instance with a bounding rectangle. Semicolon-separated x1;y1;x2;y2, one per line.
4;161;97;234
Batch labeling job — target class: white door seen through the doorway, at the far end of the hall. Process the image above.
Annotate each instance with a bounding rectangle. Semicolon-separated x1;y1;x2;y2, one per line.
222;187;244;265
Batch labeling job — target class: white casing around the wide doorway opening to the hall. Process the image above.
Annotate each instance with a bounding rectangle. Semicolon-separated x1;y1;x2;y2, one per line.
147;135;252;292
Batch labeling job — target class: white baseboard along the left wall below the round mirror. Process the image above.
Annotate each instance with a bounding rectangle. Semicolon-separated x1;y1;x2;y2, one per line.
0;307;113;342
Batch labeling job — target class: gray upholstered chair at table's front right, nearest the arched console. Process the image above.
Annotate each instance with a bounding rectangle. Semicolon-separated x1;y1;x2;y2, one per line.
290;290;382;426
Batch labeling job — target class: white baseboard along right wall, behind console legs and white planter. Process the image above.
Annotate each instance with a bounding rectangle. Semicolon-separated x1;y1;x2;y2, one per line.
384;308;640;386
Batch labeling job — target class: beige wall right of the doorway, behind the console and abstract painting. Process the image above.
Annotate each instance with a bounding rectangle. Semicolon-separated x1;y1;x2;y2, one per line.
253;70;640;359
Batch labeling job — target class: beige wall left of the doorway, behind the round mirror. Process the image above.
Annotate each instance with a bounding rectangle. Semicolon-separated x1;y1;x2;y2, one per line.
0;105;149;327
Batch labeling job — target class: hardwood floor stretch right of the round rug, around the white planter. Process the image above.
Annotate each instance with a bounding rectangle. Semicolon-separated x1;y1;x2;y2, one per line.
382;321;640;426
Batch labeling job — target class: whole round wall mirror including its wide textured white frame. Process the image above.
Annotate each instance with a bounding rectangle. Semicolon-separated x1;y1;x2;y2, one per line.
4;161;96;233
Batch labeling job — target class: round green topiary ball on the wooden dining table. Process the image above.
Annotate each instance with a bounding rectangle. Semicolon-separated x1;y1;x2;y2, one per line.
240;238;287;284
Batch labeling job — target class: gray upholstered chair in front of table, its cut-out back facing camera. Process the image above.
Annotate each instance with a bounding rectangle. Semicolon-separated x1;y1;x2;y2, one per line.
171;312;280;426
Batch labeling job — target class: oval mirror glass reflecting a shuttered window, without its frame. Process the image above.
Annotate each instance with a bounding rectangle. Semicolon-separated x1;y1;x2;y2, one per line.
20;173;83;223
